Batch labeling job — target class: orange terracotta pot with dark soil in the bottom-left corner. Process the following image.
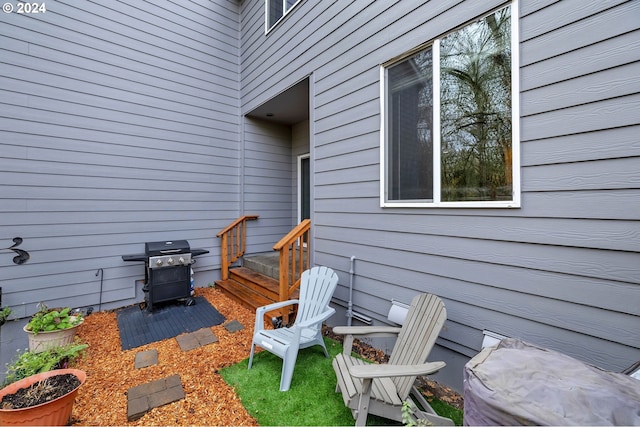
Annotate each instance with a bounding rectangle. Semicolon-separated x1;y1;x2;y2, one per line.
0;369;87;426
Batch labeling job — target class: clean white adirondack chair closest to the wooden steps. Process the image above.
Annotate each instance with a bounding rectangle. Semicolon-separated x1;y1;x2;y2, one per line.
249;267;338;391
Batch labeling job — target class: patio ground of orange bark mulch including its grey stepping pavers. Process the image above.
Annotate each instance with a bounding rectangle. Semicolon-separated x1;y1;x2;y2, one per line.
2;288;462;426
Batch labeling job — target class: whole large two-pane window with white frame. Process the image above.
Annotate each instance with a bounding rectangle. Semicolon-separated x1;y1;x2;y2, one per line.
381;3;520;207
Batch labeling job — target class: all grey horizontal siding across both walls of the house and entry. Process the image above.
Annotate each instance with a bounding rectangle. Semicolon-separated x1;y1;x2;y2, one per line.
0;0;640;390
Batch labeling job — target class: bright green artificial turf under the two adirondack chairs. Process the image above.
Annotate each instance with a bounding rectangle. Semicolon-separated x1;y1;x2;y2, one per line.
219;338;462;426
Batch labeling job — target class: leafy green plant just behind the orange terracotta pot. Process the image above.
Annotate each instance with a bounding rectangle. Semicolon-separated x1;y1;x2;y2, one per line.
4;341;88;385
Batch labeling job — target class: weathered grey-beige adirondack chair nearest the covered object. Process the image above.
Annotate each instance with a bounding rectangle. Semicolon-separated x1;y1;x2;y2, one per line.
333;294;453;426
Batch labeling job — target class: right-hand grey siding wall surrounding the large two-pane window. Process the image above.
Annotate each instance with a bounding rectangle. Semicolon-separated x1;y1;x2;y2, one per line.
241;0;640;388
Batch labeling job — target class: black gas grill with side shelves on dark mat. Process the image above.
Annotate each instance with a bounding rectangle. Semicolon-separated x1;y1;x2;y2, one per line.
122;240;209;311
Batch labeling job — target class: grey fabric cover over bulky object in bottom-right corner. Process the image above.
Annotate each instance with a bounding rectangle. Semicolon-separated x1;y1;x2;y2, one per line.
464;338;640;426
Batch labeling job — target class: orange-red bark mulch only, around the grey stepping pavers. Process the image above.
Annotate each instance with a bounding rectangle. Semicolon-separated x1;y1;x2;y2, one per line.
71;288;258;426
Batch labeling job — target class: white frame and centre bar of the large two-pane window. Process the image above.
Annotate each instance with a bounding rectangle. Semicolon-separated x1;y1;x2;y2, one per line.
380;0;520;208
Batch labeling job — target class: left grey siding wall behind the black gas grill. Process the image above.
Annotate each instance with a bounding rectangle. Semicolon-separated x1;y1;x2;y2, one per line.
0;0;241;317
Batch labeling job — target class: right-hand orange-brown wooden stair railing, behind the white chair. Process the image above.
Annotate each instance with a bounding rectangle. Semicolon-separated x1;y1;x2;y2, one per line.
273;219;311;301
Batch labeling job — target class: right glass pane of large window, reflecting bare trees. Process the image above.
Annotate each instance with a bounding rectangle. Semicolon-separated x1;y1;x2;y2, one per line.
440;8;512;201
